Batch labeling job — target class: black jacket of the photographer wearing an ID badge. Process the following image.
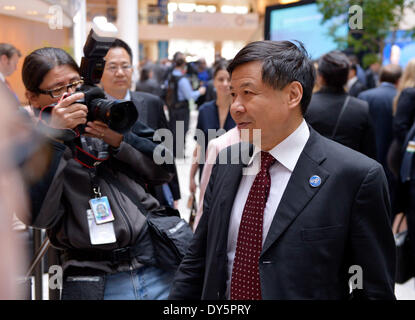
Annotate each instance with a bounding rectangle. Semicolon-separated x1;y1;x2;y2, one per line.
22;121;174;272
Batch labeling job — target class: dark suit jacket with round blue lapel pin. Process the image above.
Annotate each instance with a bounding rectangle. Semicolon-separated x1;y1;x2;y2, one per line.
169;129;395;300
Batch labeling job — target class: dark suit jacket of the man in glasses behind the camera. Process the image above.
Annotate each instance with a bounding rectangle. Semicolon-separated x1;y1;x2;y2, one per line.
130;92;181;204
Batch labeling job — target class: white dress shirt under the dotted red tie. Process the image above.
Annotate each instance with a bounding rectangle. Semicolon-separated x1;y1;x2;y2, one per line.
227;120;310;298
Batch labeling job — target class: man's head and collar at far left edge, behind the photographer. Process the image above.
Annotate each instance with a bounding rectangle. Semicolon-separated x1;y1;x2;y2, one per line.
0;43;22;104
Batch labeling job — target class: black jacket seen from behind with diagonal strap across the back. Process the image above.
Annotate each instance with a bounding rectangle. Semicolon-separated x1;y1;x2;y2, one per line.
305;88;376;159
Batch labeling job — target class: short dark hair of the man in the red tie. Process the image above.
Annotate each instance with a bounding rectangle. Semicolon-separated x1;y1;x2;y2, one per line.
228;40;315;114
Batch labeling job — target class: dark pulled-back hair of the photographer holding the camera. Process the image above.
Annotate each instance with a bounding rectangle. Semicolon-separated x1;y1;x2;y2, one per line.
22;48;79;93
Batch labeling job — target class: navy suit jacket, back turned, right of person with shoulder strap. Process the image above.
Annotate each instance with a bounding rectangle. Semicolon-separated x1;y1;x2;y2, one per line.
358;82;396;168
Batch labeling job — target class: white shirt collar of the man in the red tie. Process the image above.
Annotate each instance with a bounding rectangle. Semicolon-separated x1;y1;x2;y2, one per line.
249;119;310;172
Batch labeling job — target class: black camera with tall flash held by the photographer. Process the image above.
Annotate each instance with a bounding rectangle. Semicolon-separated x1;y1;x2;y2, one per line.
77;30;138;133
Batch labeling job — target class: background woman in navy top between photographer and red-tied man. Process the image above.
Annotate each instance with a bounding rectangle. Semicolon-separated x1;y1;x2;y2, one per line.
189;63;235;194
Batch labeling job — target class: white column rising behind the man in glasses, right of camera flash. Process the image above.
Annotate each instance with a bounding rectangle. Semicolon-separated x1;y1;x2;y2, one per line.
117;0;138;83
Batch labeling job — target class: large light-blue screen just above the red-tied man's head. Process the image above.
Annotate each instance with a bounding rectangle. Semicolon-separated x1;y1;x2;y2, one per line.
269;3;348;59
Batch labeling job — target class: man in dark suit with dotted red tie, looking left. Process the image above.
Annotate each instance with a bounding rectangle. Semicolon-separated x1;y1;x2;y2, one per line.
169;41;395;300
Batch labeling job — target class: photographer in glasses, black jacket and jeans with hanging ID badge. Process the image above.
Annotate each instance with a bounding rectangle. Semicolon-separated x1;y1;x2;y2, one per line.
22;48;173;299
